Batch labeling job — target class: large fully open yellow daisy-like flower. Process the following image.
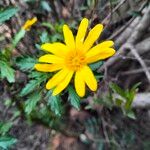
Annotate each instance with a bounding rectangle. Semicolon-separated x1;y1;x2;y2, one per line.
35;18;115;97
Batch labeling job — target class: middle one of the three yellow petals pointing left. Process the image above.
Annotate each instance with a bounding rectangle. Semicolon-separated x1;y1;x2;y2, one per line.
39;54;64;64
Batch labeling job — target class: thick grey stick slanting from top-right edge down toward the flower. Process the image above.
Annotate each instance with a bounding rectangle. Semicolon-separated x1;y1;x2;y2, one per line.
98;6;150;72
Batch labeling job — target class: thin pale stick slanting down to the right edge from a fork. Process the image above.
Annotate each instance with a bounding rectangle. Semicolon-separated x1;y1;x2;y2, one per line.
126;44;150;83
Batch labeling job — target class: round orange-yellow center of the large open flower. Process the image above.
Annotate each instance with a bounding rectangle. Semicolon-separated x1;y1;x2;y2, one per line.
66;51;86;71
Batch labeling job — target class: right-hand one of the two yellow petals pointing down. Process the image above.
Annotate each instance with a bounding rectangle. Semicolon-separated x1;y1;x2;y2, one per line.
81;66;97;91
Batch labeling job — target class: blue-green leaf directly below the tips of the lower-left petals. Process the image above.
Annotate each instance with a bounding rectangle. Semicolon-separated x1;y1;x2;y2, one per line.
47;91;62;116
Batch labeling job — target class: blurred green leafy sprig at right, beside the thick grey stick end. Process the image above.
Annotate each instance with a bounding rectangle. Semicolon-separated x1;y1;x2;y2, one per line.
92;83;140;119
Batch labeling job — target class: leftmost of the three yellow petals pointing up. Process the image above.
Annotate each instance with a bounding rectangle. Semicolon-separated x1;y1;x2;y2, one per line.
63;25;75;50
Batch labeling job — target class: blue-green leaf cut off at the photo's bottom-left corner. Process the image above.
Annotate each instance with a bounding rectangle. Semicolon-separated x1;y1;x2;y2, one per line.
0;136;17;150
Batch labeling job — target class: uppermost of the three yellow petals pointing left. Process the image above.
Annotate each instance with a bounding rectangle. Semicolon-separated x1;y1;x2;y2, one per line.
41;42;69;57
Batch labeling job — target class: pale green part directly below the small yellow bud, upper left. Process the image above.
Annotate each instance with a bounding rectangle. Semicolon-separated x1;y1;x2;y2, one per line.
12;29;26;47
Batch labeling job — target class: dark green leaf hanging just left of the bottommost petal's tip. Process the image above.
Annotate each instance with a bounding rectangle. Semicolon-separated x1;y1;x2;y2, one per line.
68;86;81;110
